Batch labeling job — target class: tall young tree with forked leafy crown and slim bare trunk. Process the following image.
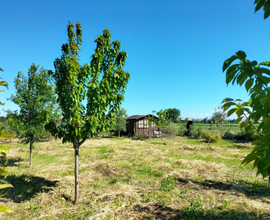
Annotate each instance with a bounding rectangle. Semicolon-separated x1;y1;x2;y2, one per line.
47;22;130;204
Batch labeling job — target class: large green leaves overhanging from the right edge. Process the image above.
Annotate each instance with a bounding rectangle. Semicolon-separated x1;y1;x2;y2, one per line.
223;0;270;180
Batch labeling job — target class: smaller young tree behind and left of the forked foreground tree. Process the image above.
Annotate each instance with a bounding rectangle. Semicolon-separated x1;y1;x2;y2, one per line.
9;63;57;168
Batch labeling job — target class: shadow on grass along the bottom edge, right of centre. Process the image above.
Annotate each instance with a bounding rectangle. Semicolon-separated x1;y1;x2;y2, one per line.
132;202;270;220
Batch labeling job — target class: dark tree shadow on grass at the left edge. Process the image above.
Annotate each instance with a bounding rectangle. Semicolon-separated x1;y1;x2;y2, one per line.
1;174;58;203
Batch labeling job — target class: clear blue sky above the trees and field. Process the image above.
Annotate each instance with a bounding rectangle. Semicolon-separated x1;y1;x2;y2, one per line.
0;0;270;118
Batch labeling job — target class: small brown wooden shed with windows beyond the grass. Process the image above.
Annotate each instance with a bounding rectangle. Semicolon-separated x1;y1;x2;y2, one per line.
127;114;161;137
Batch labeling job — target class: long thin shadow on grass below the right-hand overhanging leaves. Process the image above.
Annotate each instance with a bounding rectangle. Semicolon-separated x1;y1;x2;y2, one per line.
177;178;270;198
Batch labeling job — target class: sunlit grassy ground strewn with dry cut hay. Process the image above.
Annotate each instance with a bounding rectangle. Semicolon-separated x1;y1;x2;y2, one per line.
0;137;270;219
